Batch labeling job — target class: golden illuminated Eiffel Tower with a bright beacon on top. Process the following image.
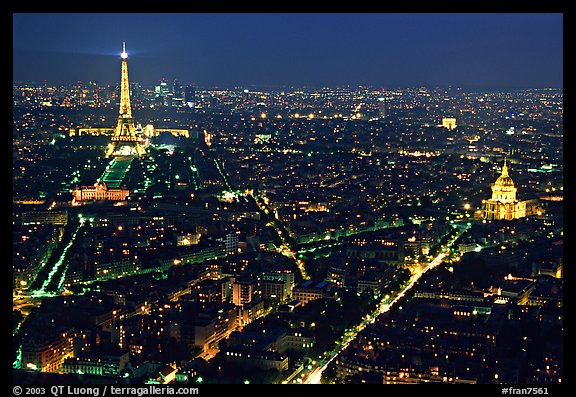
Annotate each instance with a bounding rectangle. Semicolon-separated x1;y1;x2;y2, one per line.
105;43;146;157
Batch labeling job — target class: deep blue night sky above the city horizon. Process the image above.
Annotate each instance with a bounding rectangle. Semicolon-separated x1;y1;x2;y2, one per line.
13;13;563;89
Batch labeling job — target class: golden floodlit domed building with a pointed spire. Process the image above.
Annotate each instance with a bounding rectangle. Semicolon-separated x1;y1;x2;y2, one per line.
482;160;537;220
